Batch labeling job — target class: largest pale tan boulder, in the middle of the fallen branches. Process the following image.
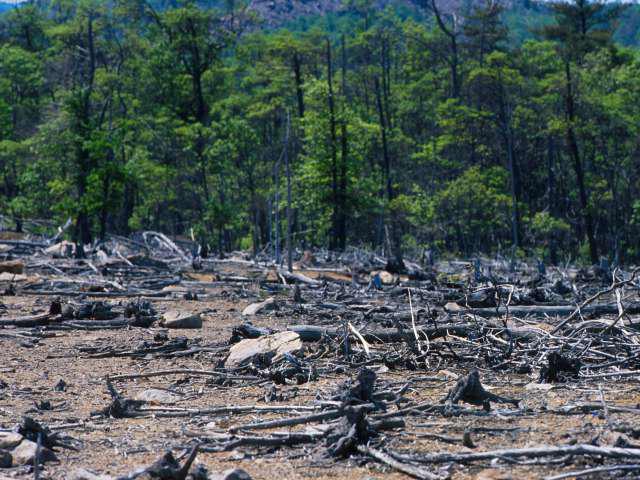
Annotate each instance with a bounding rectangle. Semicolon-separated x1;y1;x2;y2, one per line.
224;332;302;368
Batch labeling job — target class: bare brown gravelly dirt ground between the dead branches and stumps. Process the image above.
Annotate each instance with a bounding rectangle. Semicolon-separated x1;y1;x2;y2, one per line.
0;262;640;480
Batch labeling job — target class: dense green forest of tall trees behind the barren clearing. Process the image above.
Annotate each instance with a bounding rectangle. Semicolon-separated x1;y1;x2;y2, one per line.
0;0;640;267
